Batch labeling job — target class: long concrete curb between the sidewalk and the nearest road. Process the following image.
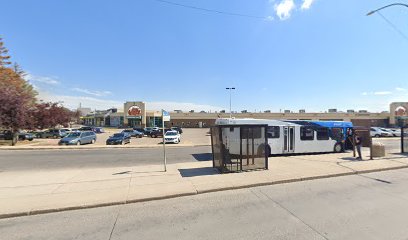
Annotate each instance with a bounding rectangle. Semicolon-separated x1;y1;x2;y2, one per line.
0;165;408;219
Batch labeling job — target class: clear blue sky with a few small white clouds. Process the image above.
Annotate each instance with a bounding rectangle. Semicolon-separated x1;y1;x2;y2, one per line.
0;0;408;112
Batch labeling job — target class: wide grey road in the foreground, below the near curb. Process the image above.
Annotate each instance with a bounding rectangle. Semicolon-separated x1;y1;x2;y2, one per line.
0;169;408;240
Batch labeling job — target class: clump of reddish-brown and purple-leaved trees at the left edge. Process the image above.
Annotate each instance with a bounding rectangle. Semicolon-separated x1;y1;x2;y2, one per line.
0;38;76;145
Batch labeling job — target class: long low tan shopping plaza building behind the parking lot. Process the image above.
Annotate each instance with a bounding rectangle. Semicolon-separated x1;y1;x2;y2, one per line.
78;101;408;128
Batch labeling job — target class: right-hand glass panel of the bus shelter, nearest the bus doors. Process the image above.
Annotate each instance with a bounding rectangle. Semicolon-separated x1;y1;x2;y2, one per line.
240;126;268;171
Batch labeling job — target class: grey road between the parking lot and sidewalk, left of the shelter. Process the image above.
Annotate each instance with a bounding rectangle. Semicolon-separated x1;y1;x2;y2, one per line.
0;146;212;171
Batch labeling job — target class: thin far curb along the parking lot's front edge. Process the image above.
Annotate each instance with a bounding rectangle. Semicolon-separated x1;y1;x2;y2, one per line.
0;144;211;151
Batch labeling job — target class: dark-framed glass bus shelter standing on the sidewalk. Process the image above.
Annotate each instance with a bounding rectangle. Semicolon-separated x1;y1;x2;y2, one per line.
211;124;269;173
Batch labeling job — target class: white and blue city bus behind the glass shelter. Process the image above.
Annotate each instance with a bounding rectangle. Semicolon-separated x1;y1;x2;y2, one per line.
215;118;353;155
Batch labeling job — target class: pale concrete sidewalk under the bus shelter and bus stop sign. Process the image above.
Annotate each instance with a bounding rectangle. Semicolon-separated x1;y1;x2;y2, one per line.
0;150;408;218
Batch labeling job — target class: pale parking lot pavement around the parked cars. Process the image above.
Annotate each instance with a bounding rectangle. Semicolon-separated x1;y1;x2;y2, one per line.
11;128;211;148
